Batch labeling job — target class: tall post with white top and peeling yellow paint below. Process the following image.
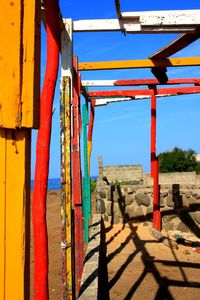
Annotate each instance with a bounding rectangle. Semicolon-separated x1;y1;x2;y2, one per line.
60;19;73;300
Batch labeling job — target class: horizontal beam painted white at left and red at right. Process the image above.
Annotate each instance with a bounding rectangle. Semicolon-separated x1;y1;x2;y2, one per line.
81;78;200;87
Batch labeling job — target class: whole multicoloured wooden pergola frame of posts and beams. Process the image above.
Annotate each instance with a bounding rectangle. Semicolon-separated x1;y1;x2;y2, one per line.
0;0;200;300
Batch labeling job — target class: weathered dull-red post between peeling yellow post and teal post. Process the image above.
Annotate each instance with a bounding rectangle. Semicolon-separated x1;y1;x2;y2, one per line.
71;57;84;297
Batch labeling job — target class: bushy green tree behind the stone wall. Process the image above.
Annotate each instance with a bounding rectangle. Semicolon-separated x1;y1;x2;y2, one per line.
158;147;200;173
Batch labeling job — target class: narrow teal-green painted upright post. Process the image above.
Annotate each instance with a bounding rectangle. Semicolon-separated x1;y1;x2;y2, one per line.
82;104;91;243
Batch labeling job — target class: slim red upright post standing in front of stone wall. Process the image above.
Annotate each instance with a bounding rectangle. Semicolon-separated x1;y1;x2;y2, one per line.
150;86;161;231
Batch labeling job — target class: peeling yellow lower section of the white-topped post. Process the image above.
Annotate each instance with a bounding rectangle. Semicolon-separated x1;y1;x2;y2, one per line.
61;76;73;300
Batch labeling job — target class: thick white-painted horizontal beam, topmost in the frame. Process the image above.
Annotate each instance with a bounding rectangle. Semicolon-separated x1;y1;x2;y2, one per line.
73;10;200;33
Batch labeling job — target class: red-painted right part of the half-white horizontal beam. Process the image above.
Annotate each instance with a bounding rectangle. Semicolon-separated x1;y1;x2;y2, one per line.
114;78;200;86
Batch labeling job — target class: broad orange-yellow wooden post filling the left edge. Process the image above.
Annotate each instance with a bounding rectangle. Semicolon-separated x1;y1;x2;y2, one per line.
0;0;41;300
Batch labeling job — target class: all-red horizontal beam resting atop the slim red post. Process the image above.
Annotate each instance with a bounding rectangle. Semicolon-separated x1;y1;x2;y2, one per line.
88;86;200;98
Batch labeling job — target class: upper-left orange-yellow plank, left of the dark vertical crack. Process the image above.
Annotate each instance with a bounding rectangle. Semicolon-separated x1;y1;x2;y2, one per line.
0;0;22;128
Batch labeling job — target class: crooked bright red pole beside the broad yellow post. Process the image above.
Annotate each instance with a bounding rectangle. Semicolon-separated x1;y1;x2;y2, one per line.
32;0;60;300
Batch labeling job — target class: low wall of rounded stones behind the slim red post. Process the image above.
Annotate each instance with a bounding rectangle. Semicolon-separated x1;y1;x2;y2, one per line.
96;179;200;235
